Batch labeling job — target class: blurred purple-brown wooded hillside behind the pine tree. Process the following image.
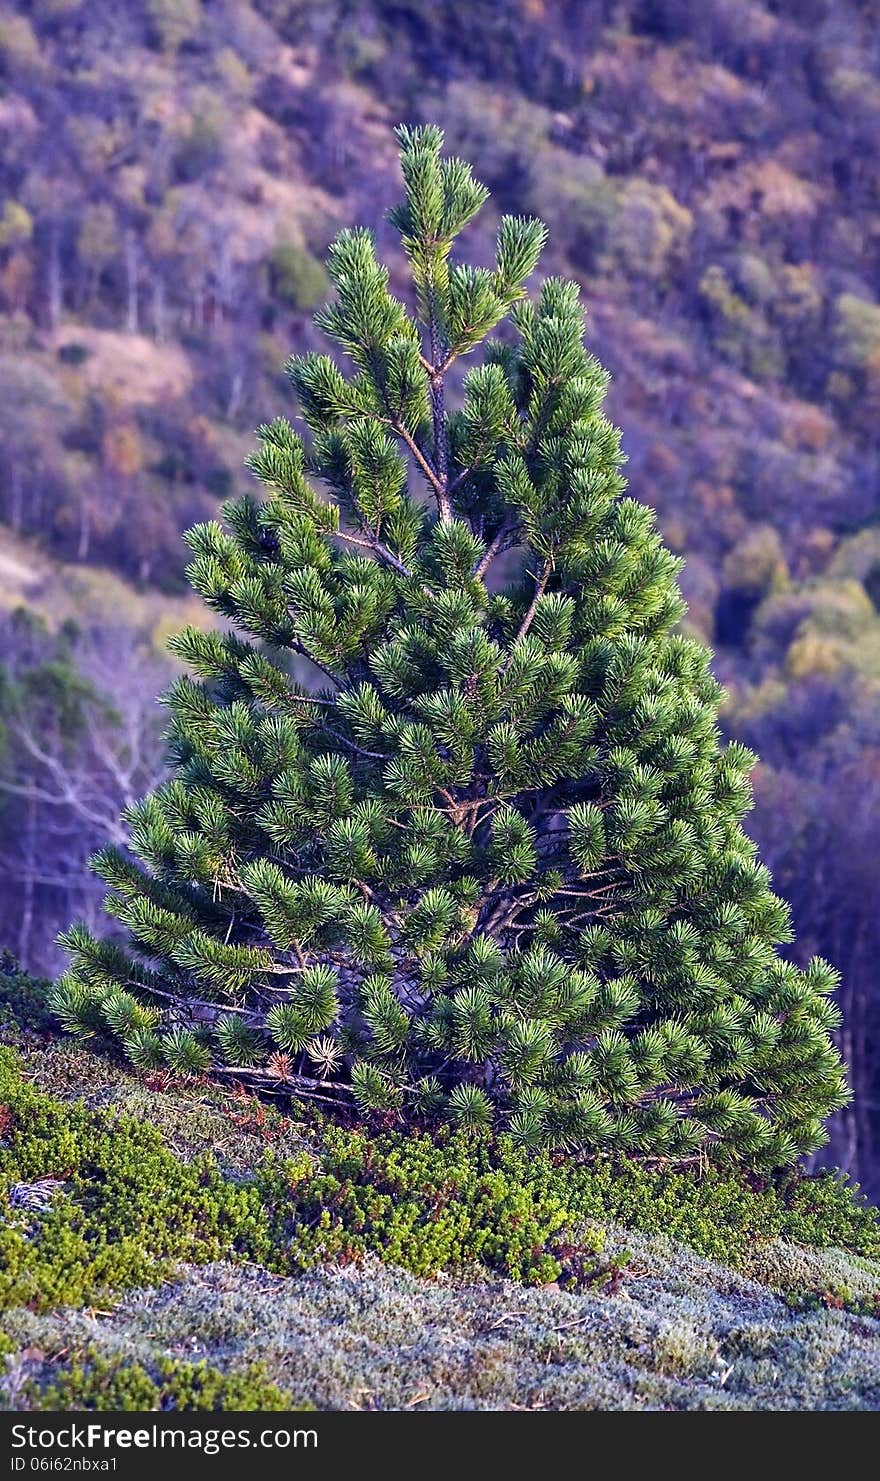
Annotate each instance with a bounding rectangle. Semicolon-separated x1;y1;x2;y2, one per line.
0;0;880;1195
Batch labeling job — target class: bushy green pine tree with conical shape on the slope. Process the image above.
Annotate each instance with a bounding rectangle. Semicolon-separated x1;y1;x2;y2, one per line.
55;127;846;1167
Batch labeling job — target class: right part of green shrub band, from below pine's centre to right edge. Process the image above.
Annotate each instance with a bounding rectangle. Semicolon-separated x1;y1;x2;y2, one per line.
273;1126;880;1283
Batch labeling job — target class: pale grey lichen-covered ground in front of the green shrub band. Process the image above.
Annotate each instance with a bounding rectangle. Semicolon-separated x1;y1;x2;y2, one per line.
6;1234;880;1410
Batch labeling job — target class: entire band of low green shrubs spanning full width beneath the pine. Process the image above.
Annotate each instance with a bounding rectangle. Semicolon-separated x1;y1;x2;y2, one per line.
0;1049;880;1311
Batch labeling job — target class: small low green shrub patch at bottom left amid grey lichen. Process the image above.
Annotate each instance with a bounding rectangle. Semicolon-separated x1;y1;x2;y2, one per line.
27;1346;293;1411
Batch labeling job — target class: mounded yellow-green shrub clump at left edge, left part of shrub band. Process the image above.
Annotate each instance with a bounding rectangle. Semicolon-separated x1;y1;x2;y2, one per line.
0;1050;271;1309
